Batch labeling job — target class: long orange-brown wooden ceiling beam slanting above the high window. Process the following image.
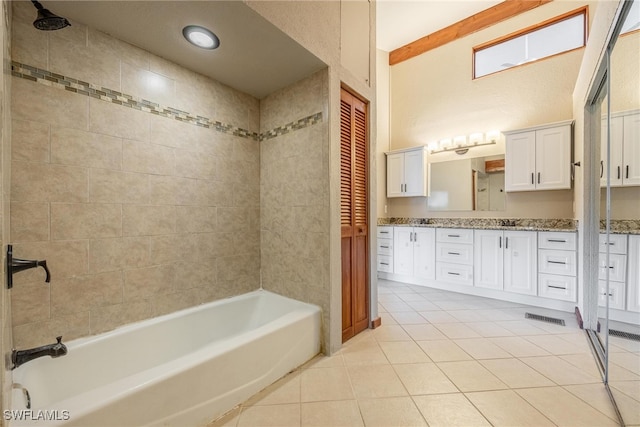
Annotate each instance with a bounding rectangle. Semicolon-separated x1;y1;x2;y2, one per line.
389;0;552;65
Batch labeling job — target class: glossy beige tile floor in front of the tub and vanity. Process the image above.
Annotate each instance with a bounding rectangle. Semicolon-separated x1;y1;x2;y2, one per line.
209;280;640;427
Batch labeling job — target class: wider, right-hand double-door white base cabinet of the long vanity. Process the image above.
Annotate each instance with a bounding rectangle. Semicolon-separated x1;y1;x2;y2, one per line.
474;230;537;295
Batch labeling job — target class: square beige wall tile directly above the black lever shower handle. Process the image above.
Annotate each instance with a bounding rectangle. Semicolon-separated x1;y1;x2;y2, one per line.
11;202;49;243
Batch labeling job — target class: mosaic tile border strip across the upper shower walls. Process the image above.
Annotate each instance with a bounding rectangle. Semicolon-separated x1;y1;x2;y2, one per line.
11;61;323;141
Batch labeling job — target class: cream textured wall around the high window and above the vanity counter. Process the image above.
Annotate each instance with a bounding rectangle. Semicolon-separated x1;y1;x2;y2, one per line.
378;2;596;218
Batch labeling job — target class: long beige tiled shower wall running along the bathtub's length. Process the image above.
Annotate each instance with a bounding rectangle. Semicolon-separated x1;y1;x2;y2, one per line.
11;2;262;347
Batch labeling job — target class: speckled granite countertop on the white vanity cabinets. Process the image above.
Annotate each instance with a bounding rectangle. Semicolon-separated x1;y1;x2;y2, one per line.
378;218;640;234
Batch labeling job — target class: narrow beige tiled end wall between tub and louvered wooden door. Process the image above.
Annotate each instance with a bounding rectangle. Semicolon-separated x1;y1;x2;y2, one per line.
260;69;330;352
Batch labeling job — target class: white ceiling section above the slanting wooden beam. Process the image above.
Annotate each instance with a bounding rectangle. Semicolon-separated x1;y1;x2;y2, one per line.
376;0;502;51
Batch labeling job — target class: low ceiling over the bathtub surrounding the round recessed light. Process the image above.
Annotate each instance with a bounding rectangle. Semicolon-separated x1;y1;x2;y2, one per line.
46;0;326;98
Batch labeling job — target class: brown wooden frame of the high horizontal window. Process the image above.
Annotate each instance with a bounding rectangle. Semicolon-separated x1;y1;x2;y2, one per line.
471;5;589;80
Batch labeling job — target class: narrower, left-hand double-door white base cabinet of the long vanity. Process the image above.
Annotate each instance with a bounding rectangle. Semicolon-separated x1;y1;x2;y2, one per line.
393;227;435;280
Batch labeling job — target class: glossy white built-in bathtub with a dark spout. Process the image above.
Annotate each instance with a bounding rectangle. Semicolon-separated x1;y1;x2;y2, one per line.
10;290;320;427
